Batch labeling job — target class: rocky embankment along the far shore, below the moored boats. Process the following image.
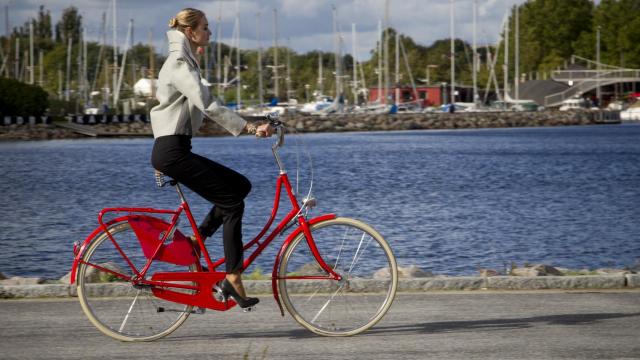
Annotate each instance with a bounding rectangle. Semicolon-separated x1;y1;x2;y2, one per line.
0;110;619;141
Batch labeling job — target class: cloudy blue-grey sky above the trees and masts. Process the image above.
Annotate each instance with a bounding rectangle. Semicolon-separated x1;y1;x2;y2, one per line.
6;0;525;61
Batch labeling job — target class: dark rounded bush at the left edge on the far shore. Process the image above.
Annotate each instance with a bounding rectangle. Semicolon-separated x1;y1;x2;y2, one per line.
0;77;49;116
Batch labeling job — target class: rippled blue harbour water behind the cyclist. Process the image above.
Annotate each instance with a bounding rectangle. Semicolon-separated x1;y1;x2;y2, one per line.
0;124;640;279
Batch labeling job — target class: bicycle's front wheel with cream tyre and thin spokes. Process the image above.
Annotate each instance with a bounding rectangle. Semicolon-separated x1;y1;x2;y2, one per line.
278;218;398;336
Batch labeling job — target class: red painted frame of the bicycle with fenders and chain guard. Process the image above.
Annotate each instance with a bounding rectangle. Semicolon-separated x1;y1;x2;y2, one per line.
71;133;341;316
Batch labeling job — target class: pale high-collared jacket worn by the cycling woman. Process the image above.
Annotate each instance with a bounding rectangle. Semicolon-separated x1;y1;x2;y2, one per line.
150;30;247;138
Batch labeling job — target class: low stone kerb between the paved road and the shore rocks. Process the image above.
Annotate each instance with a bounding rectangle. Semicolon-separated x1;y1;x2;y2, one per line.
0;274;640;299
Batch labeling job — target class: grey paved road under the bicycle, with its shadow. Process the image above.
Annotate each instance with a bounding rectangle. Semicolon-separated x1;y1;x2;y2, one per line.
0;290;640;360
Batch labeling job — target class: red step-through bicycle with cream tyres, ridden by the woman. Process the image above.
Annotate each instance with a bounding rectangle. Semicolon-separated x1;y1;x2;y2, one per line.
71;118;398;341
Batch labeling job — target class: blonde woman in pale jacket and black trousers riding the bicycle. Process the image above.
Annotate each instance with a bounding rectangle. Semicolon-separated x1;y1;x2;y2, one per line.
151;8;274;308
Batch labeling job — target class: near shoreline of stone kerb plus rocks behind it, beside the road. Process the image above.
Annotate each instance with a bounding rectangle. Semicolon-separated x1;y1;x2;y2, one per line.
0;264;640;300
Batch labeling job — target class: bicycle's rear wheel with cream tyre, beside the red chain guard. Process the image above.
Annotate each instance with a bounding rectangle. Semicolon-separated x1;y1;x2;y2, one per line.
76;220;196;341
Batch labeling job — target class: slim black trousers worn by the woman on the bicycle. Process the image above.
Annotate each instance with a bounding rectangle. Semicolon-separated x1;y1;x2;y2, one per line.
151;135;251;273
